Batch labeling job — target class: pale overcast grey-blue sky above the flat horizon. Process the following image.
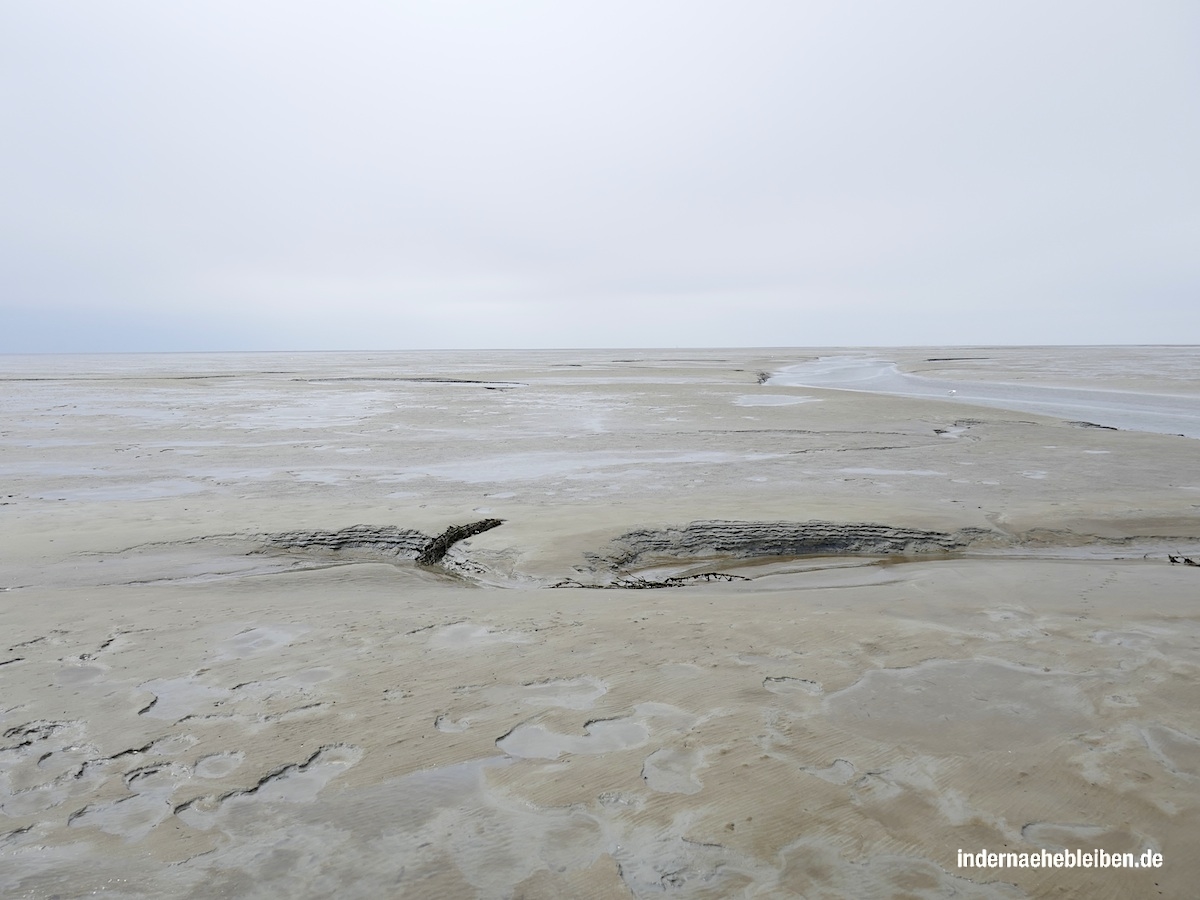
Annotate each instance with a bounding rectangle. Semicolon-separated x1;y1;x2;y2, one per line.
0;0;1200;353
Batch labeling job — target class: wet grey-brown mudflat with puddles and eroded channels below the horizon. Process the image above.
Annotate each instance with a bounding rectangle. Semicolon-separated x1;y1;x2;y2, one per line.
0;347;1200;898
